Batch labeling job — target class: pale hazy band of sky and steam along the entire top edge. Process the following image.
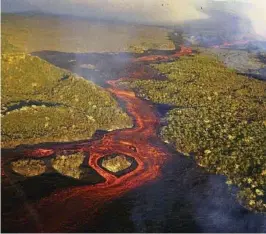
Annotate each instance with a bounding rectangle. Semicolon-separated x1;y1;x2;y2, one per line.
2;0;266;37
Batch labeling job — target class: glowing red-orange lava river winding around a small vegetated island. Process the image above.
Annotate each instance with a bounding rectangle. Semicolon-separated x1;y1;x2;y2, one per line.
4;47;191;232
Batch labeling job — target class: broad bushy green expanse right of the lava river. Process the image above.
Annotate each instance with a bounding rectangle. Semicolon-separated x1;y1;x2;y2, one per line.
131;55;266;212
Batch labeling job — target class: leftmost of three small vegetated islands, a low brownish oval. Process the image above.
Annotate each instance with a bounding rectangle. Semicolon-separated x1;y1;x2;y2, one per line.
11;159;46;177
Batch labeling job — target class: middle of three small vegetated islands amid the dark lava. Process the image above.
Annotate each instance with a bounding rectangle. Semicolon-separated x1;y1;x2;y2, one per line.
51;153;88;179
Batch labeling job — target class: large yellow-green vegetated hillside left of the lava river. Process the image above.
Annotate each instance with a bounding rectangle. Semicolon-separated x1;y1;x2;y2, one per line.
1;39;132;148
